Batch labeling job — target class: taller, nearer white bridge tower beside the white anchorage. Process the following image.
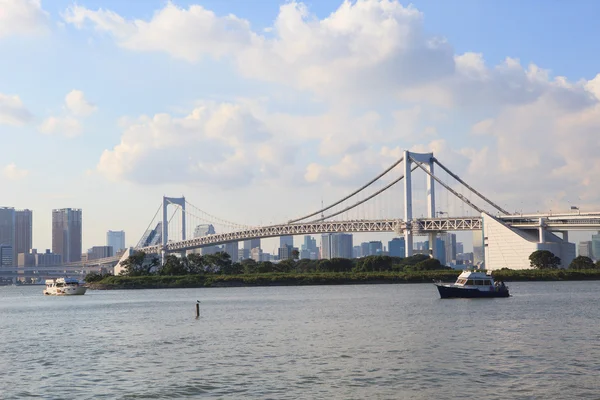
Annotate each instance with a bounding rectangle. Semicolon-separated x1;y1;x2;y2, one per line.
404;150;436;257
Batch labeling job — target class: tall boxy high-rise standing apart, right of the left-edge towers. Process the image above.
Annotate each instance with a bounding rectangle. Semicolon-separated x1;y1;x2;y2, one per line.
52;208;82;263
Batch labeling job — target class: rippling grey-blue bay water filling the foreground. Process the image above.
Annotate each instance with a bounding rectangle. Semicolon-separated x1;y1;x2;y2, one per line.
0;282;600;399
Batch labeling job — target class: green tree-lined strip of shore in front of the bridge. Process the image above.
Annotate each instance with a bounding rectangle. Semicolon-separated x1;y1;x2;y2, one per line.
86;252;600;290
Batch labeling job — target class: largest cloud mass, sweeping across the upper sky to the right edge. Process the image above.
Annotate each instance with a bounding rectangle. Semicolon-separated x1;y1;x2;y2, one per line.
69;0;600;209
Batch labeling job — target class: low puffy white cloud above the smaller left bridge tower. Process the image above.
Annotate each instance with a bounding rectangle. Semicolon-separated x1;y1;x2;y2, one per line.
97;102;294;187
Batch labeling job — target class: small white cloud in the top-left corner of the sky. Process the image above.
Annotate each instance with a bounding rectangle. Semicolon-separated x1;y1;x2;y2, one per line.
0;0;48;39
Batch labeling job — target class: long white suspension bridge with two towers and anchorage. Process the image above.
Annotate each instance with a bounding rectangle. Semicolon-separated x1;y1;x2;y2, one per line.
4;151;600;278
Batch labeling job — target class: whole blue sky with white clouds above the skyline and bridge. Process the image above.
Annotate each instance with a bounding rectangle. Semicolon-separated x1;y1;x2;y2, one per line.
0;0;600;251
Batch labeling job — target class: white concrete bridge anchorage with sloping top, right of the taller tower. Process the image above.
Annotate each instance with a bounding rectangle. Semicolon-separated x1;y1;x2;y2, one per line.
481;213;575;271
